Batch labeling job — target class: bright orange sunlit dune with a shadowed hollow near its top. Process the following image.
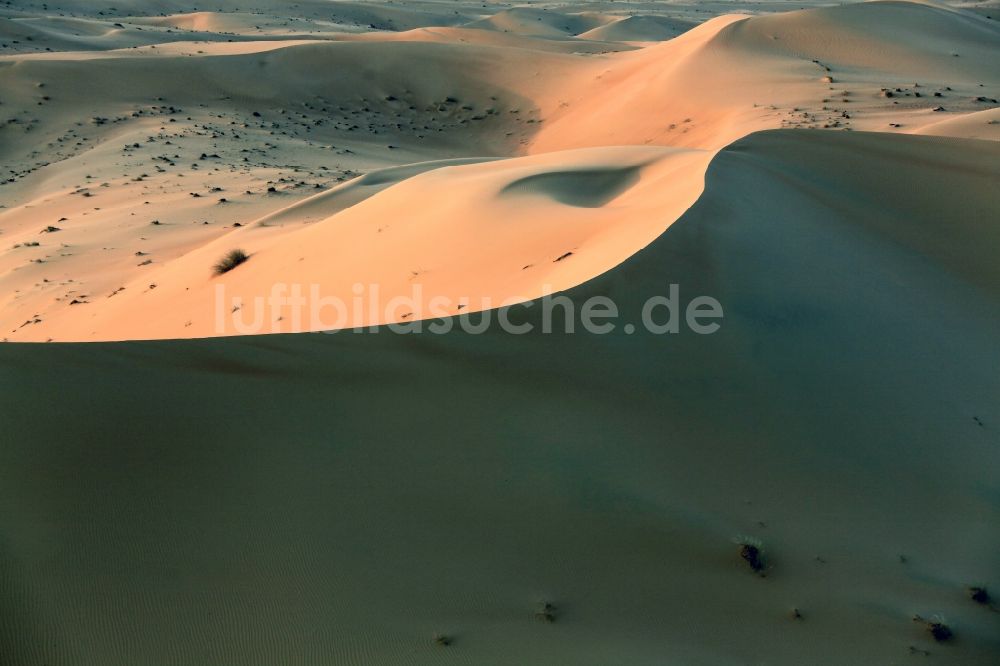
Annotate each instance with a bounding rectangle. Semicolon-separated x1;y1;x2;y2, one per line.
52;147;709;340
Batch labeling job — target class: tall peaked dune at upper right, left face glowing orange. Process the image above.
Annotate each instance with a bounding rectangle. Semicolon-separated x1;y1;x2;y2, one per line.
531;2;1000;152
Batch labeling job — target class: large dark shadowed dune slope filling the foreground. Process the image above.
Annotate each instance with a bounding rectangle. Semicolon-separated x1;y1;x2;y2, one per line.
0;131;1000;666
